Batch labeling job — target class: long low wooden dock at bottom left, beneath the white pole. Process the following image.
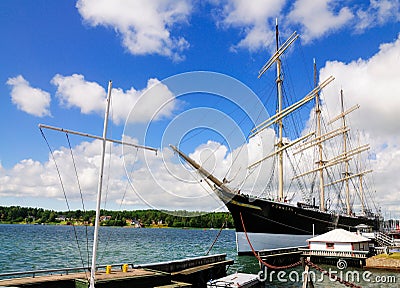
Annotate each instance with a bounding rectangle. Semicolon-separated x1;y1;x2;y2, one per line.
0;254;233;288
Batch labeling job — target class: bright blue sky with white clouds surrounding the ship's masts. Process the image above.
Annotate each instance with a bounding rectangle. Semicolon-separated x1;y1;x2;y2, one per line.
0;0;400;215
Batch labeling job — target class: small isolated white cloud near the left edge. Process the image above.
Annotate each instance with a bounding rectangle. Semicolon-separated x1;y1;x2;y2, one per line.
7;75;51;117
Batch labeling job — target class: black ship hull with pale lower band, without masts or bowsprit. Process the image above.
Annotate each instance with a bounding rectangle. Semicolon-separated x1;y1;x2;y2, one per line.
215;189;379;254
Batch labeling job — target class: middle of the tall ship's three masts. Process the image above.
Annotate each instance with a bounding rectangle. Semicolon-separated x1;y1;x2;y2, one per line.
314;59;326;211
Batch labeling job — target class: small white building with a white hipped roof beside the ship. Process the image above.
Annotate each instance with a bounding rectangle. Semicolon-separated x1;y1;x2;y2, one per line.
307;229;370;251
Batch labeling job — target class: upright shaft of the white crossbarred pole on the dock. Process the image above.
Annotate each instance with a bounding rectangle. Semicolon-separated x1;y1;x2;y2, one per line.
89;81;112;288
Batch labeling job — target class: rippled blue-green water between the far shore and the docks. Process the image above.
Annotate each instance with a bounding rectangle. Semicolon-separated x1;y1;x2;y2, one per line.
0;225;400;287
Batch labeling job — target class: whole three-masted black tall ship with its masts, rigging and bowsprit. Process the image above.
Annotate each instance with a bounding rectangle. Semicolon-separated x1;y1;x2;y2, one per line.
171;20;380;253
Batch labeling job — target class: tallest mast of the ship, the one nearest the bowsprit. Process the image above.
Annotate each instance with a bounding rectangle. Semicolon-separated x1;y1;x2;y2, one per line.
275;19;284;201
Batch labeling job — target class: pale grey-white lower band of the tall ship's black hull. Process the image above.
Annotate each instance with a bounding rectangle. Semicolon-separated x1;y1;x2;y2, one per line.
236;232;312;254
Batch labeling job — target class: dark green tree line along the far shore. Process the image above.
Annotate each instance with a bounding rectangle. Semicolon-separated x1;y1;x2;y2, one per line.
0;206;234;228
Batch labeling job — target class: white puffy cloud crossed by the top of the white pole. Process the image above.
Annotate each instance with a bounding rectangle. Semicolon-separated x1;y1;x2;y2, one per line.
51;74;177;125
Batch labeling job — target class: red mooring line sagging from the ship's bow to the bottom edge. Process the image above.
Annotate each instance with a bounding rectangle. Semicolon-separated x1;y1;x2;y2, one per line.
239;212;362;288
